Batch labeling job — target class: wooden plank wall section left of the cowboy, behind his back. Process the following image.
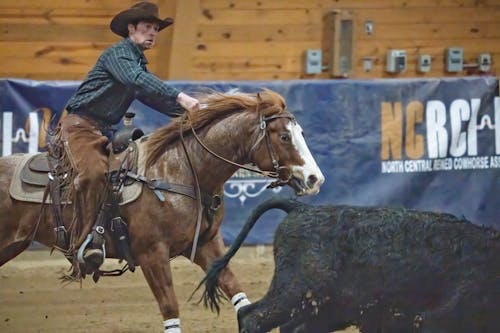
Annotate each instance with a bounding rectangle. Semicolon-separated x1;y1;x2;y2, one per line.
0;0;139;80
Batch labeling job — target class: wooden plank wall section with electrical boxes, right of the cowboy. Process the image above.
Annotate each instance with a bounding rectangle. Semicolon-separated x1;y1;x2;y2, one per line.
193;0;500;80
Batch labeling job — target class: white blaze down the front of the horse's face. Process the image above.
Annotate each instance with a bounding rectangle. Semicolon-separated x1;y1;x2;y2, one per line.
287;121;325;195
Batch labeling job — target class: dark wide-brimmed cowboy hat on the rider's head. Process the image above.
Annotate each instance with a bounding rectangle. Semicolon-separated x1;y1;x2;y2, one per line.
109;1;174;37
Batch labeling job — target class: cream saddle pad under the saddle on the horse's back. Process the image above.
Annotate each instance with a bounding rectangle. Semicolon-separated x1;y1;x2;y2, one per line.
9;143;145;205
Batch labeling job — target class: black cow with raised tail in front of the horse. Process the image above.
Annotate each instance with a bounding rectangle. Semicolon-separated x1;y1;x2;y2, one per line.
198;199;500;333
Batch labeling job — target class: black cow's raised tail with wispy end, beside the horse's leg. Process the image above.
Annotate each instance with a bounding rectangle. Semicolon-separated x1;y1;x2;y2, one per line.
191;198;303;313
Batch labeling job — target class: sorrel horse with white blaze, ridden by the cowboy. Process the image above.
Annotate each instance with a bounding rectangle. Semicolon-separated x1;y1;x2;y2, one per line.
0;90;324;332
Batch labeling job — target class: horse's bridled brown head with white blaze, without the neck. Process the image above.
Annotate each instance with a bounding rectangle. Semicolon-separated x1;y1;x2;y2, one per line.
251;91;325;195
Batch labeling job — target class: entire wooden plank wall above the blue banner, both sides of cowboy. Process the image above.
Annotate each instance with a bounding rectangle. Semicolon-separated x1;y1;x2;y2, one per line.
0;0;500;80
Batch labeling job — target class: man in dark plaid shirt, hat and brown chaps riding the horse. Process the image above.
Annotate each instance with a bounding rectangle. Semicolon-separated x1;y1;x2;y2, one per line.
59;1;200;273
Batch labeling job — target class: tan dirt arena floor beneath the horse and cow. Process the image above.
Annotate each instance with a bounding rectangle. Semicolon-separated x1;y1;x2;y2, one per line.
0;246;358;333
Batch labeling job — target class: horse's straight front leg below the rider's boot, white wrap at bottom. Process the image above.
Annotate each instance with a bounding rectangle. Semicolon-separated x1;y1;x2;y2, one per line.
136;241;181;333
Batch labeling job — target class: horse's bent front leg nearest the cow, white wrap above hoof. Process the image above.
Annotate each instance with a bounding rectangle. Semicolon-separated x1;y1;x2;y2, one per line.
194;231;250;312
